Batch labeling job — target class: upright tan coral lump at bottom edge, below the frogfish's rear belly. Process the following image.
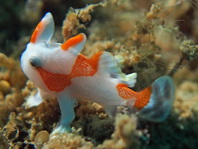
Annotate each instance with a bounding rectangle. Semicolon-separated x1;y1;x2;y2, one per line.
98;115;140;149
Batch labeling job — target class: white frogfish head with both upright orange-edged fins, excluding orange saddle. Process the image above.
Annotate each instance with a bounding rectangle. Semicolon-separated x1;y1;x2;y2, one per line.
21;12;86;91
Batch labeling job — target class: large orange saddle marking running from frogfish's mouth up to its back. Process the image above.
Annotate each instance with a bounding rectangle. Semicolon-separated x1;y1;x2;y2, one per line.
37;52;103;92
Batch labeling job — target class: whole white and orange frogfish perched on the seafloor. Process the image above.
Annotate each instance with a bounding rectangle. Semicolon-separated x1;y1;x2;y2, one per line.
21;13;175;133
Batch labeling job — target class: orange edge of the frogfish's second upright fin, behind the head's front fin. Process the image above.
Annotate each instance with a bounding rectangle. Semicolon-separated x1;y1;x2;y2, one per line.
61;34;84;50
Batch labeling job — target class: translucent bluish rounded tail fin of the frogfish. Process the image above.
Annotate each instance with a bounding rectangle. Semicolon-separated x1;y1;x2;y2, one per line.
139;76;175;122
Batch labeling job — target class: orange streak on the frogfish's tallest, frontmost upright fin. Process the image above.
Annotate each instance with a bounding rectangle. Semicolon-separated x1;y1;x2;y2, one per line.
30;21;44;43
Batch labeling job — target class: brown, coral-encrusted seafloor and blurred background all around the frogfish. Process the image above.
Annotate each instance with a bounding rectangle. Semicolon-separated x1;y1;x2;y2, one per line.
0;0;198;149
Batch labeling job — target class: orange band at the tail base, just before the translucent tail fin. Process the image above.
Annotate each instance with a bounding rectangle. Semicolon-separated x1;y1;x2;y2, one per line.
116;84;152;109
